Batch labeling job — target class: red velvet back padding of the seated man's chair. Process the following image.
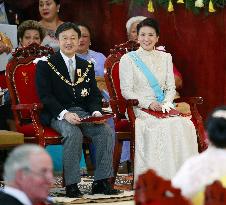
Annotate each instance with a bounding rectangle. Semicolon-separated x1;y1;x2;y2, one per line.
14;63;40;118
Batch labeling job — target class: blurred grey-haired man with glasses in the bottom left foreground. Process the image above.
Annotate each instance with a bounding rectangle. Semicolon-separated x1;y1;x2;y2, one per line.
0;144;53;205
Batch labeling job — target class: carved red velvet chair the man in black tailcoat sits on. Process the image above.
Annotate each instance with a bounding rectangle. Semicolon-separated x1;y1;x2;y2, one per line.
6;44;61;146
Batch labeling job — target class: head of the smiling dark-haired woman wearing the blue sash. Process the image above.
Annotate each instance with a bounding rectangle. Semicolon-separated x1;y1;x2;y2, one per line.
137;18;160;51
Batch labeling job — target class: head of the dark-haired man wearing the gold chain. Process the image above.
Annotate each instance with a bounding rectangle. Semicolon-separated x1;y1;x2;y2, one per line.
55;22;81;58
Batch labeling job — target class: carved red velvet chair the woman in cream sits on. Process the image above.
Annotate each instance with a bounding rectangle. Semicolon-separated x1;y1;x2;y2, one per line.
105;41;207;187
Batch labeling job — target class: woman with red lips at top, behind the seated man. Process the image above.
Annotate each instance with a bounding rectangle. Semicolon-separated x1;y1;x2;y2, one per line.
39;0;63;52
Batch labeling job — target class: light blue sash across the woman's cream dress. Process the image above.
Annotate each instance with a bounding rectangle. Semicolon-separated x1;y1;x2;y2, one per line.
128;51;165;102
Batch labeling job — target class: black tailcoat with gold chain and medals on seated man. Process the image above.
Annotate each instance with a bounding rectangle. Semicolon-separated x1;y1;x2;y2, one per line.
36;51;102;125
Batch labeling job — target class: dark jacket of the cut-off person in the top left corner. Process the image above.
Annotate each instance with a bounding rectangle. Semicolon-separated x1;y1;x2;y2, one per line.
4;1;23;25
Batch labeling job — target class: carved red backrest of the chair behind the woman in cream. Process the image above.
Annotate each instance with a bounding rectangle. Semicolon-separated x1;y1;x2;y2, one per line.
104;41;139;119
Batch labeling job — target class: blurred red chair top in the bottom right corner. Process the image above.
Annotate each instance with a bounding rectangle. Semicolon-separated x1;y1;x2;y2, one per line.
204;181;226;205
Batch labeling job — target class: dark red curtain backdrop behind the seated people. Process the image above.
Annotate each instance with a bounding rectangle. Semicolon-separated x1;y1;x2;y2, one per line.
23;0;226;118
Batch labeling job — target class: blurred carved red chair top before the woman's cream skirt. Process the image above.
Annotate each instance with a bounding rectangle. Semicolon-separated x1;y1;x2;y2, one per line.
134;170;191;205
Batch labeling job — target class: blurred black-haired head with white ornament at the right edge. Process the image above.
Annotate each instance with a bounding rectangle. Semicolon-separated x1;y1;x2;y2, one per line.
205;106;226;149
